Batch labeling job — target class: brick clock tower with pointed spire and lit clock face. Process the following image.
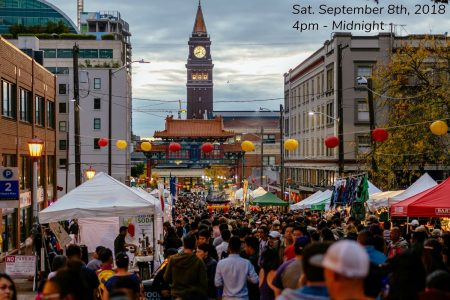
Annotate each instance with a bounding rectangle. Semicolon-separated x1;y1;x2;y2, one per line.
186;1;214;119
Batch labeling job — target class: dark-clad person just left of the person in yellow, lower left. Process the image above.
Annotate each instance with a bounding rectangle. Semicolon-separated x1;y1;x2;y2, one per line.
65;244;100;300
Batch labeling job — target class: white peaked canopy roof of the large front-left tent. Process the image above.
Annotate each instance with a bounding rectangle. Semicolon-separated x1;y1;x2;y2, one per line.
39;173;157;223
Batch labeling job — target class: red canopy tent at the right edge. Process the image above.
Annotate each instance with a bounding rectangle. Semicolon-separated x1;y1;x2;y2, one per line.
391;177;450;218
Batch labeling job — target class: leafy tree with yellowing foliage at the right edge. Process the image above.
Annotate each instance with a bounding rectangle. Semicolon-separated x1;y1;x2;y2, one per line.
368;36;450;188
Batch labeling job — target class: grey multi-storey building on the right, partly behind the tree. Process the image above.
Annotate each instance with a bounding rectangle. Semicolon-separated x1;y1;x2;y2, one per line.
284;33;394;194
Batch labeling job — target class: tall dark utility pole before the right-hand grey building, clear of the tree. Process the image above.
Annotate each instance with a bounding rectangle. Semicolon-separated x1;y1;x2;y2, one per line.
337;44;348;176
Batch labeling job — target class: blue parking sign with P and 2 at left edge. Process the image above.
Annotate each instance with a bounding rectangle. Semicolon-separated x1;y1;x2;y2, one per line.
0;167;19;208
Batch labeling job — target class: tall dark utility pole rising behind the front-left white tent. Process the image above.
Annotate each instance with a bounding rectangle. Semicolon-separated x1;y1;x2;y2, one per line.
72;44;81;186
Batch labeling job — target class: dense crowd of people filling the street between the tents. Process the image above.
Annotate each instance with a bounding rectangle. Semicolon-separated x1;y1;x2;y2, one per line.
0;193;450;300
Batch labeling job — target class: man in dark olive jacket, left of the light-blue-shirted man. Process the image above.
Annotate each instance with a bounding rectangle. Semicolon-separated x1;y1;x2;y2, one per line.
164;234;208;299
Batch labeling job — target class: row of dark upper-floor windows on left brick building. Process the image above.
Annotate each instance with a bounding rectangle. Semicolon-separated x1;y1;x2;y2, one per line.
1;80;55;129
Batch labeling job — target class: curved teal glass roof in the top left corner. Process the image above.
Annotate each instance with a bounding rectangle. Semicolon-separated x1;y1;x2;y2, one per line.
0;0;78;34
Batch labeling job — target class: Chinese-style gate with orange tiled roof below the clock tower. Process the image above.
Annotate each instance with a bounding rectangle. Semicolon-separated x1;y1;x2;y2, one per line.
142;116;244;192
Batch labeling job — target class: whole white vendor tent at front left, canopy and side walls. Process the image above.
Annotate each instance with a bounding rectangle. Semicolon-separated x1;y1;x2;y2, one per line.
39;173;162;278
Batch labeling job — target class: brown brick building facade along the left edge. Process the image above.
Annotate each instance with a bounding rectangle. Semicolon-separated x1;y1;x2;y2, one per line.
0;38;56;252
